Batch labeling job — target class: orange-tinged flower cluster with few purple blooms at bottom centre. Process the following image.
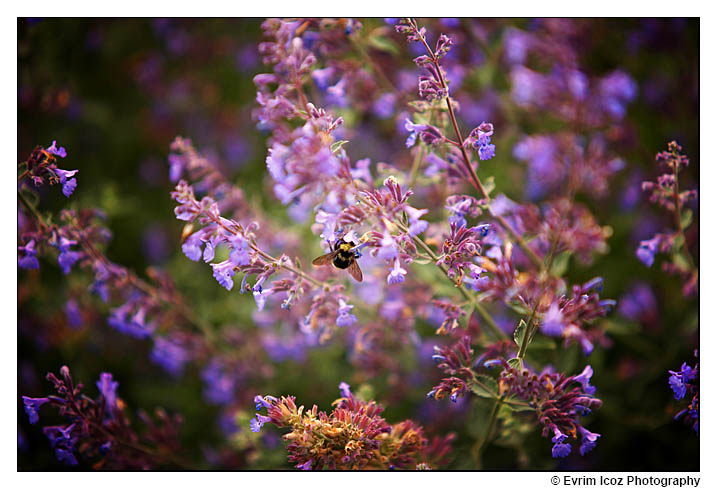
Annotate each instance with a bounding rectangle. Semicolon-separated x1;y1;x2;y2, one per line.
251;382;450;470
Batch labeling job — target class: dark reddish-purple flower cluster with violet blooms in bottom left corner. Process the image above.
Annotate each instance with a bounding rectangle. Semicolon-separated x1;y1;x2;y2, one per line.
22;366;186;470
